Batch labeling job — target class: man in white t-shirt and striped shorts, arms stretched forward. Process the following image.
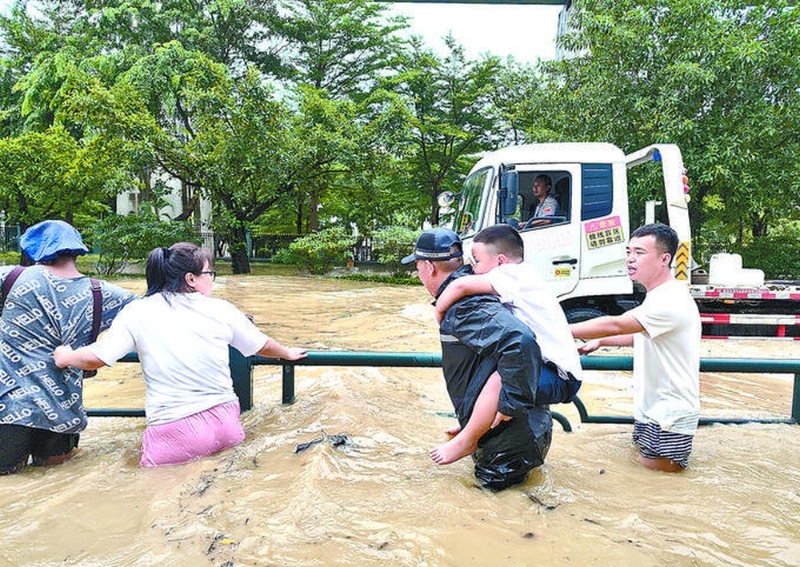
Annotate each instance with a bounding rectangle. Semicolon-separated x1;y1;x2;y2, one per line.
571;223;701;472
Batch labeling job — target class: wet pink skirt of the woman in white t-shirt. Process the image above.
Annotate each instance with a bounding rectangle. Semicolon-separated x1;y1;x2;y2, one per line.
139;400;244;467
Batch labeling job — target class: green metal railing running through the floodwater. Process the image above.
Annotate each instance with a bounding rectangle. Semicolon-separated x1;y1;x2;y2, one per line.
87;348;800;431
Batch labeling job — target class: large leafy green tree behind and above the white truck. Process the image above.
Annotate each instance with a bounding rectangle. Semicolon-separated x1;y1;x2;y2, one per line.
526;0;800;246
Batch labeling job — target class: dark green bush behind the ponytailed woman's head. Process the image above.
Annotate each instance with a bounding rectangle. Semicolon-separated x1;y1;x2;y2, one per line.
89;212;200;275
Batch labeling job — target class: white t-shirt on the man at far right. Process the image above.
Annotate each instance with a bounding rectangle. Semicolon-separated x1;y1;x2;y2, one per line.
626;280;702;435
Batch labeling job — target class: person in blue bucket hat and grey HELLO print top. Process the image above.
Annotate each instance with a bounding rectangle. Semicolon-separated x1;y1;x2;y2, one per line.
0;220;137;474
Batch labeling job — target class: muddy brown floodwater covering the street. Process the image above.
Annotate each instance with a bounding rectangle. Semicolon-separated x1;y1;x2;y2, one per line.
0;276;800;567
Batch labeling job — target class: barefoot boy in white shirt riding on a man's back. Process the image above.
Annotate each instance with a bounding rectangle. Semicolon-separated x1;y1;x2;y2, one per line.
431;225;582;465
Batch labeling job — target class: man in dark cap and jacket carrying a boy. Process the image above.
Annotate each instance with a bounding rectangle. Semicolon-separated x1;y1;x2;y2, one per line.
403;228;552;490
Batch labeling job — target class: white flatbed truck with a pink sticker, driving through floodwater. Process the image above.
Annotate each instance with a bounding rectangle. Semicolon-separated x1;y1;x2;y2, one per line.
444;143;800;339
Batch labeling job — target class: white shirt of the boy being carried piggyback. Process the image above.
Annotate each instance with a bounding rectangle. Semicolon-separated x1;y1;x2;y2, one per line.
486;262;582;380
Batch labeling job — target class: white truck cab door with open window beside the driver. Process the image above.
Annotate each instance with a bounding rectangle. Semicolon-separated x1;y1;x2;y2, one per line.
516;164;581;297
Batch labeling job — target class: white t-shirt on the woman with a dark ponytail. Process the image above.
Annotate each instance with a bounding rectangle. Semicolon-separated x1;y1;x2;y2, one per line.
89;293;269;425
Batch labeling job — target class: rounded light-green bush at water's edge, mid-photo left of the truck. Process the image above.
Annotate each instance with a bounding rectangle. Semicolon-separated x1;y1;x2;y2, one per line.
273;226;356;274
